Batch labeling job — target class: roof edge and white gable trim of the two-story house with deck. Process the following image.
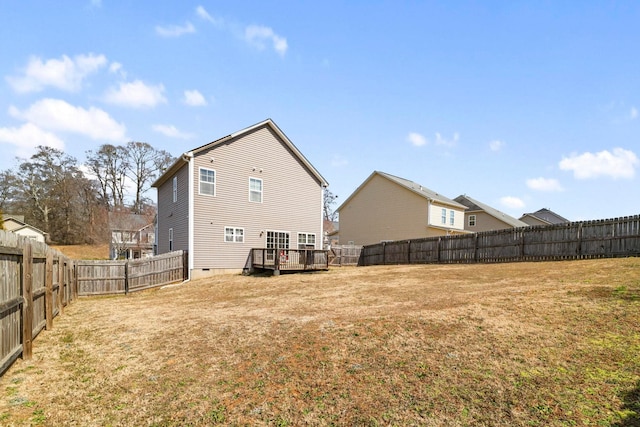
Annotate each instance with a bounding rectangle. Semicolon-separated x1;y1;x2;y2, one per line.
151;119;329;187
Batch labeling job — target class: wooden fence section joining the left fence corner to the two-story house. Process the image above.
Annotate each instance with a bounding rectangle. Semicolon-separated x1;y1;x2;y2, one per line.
76;251;188;296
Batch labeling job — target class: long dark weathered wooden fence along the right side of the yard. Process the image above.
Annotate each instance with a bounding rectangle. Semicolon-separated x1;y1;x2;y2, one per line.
360;215;640;265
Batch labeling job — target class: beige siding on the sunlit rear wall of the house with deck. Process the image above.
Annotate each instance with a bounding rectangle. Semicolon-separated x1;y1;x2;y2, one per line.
193;125;322;269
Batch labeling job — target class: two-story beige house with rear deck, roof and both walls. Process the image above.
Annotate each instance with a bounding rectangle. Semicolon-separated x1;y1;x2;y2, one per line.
152;119;327;278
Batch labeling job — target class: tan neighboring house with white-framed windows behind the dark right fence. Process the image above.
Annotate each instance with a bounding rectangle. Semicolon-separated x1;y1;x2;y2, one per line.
337;171;466;245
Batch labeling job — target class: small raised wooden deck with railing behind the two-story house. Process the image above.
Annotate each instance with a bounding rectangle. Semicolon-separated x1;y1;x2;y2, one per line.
251;248;329;275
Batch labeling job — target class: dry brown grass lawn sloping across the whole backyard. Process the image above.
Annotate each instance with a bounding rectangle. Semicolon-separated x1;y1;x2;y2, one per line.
0;258;640;426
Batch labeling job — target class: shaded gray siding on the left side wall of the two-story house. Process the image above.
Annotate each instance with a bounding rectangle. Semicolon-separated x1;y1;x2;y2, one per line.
157;164;189;254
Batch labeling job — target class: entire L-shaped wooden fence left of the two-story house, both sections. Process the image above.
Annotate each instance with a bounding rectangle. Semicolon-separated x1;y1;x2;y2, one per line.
0;230;187;376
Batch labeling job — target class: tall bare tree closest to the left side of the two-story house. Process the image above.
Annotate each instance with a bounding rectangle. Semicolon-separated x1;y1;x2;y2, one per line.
126;141;173;213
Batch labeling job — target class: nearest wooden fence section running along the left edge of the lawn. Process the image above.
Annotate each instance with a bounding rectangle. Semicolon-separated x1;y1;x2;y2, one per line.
0;230;78;375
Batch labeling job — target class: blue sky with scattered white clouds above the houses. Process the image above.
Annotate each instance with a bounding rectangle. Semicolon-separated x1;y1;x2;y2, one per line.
0;0;640;220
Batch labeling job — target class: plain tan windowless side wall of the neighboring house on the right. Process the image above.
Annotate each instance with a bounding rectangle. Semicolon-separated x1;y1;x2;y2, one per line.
340;175;427;245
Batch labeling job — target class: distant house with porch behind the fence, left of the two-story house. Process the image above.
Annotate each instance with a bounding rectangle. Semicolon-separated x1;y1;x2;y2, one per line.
109;212;155;259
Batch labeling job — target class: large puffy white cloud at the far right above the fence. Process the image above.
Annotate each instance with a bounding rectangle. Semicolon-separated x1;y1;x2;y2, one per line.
559;148;640;179
